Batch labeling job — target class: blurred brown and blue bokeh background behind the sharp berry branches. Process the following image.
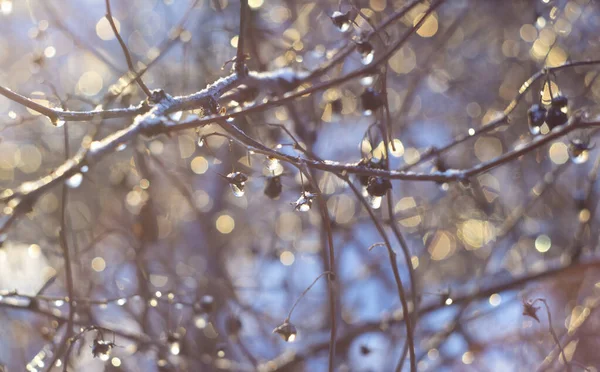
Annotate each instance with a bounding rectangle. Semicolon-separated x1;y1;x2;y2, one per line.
0;0;600;371
